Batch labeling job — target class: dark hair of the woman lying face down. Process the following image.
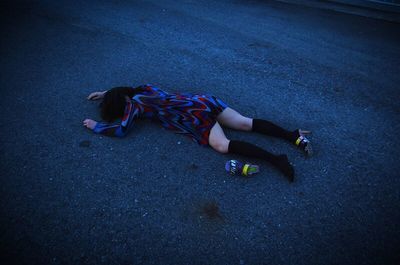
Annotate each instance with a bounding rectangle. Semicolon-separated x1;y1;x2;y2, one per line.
100;87;143;122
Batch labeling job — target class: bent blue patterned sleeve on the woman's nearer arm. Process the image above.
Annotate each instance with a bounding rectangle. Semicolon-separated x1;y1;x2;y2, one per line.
93;99;139;137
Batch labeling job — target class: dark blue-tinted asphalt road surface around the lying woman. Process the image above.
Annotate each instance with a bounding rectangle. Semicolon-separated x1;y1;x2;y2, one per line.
0;0;400;265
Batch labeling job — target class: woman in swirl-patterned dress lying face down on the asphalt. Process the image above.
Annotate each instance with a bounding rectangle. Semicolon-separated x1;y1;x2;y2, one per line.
83;84;312;182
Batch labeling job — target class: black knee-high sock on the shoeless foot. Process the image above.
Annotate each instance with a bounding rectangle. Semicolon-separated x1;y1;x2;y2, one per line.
228;140;294;181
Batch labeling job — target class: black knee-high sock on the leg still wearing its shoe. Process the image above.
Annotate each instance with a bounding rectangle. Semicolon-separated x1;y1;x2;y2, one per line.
252;119;298;143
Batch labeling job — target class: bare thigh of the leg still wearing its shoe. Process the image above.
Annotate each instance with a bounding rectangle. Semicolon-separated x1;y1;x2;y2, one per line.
217;107;253;131
